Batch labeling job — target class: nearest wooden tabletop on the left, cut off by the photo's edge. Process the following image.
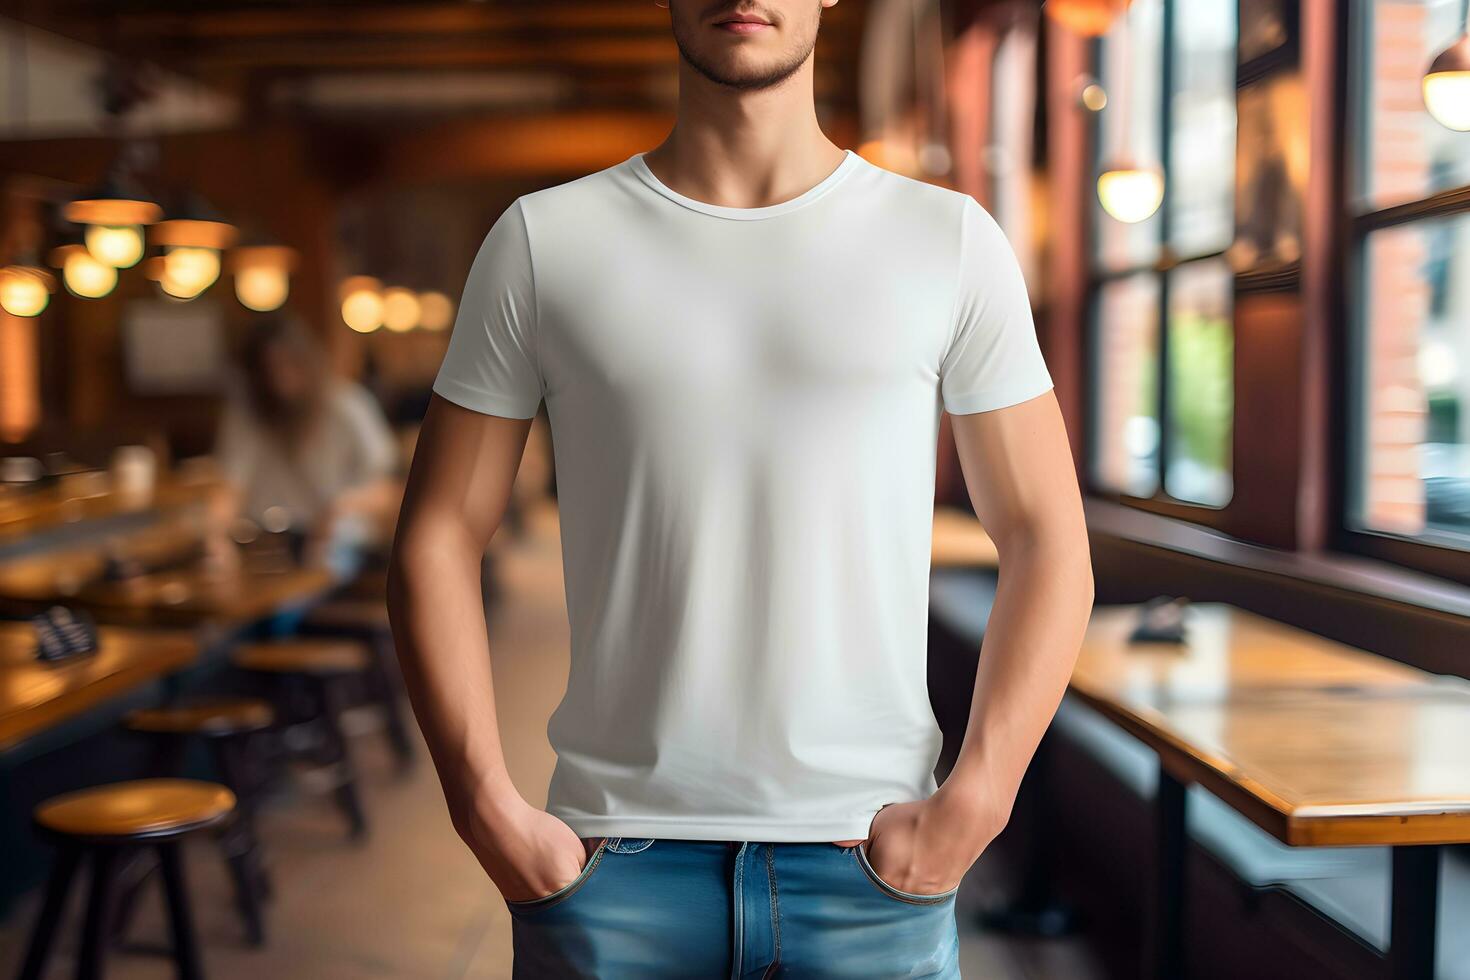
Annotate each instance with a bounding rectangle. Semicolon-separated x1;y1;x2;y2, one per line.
0;623;200;752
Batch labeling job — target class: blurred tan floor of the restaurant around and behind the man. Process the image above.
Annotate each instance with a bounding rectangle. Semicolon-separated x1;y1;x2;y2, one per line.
0;507;1101;980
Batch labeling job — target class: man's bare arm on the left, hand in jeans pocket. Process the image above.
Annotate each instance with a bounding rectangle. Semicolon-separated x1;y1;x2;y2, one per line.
388;395;587;901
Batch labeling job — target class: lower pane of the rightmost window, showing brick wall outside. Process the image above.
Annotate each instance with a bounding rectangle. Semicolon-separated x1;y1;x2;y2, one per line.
1355;215;1470;548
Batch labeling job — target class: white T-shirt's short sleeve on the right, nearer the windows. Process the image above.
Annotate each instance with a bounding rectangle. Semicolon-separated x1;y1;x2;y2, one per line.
939;197;1053;414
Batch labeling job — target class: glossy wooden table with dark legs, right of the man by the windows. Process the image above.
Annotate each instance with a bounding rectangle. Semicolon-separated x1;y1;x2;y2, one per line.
1070;604;1470;980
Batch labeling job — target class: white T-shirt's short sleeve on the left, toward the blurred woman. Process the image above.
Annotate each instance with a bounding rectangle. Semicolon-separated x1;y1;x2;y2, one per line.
434;198;545;419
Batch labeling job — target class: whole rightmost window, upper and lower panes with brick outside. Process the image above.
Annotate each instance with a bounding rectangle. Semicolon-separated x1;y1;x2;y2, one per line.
1345;0;1470;555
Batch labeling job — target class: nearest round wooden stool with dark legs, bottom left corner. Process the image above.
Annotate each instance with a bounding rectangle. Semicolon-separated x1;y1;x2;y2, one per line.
21;779;235;980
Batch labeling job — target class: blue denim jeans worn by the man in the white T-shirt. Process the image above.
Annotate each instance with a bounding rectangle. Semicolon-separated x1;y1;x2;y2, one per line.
506;837;960;980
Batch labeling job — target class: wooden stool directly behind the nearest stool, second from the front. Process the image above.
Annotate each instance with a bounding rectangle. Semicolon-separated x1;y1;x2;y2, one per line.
116;698;275;946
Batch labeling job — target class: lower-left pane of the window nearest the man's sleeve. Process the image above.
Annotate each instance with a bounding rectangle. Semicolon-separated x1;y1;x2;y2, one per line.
1092;272;1158;497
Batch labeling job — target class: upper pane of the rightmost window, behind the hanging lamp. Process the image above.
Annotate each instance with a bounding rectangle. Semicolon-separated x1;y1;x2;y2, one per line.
1358;0;1470;207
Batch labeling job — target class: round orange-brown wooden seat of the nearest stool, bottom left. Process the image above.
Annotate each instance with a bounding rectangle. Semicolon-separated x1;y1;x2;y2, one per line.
35;779;235;839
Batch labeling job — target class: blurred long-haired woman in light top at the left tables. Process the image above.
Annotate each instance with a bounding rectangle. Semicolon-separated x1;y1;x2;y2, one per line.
215;313;400;576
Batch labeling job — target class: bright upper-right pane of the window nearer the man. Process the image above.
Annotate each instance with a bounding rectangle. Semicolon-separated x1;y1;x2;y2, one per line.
1167;0;1235;256
